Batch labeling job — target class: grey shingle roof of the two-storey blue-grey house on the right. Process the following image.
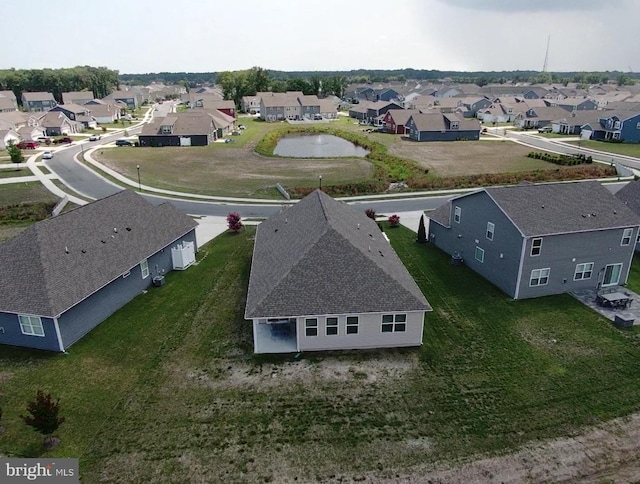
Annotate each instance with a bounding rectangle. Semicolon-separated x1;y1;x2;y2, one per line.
485;181;640;236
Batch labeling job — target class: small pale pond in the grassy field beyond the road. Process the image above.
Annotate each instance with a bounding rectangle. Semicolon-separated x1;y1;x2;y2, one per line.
273;134;369;158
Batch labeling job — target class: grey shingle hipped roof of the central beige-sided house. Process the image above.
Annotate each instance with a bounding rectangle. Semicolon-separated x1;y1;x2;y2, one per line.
245;190;431;319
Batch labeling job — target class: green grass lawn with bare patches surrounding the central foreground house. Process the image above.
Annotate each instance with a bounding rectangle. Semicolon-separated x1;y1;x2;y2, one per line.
0;228;640;482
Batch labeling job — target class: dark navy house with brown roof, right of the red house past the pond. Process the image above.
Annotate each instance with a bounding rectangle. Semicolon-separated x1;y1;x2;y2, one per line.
405;112;480;141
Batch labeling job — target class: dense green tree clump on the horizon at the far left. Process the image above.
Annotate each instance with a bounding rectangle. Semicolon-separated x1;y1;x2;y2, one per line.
0;66;120;102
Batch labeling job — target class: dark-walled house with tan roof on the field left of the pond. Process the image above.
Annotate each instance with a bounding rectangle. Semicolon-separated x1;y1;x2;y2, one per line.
138;110;217;146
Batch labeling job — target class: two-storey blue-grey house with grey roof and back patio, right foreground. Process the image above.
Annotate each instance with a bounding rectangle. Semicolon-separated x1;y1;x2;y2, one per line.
429;181;640;299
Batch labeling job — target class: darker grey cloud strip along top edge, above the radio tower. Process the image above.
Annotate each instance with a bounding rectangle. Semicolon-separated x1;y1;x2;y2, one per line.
438;0;608;13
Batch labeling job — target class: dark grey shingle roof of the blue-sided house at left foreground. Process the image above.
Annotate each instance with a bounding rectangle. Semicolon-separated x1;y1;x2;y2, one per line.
0;190;197;317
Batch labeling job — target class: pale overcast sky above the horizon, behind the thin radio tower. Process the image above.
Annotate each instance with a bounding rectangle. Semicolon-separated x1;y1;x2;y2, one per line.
0;0;640;74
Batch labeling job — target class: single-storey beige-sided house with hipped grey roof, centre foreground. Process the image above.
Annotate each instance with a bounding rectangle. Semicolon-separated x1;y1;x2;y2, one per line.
245;190;431;353
